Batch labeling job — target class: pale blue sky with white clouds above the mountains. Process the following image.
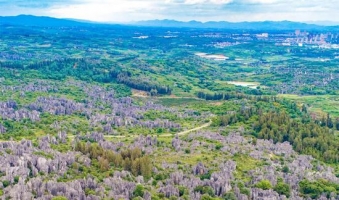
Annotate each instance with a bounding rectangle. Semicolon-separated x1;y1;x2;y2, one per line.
0;0;339;22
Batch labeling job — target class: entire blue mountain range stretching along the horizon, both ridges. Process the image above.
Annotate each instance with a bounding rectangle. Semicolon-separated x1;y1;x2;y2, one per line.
0;15;339;30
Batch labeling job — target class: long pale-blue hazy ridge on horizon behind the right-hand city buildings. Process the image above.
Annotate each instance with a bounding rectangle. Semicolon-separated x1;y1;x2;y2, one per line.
134;20;337;30
